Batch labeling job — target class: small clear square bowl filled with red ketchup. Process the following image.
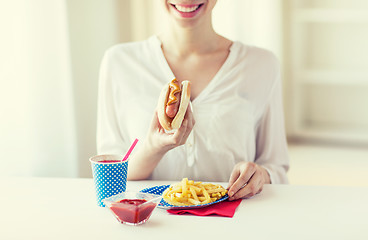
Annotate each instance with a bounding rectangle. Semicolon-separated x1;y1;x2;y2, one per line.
102;192;162;225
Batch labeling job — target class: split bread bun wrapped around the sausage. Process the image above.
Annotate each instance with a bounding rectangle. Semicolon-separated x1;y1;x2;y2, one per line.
157;80;190;131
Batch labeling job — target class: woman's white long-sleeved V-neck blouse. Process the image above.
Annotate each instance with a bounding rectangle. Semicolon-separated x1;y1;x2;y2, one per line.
97;36;289;183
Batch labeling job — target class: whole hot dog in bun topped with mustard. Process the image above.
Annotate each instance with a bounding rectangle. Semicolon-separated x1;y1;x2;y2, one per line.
157;79;190;131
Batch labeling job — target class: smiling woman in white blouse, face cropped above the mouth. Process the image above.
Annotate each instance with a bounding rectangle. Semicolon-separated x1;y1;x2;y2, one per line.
97;0;289;200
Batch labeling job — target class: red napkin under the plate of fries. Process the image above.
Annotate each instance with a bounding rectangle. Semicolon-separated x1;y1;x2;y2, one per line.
167;199;241;218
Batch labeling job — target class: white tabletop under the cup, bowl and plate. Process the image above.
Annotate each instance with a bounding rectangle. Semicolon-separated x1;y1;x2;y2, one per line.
0;178;368;240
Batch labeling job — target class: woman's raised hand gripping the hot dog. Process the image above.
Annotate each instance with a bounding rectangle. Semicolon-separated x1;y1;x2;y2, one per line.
147;106;195;154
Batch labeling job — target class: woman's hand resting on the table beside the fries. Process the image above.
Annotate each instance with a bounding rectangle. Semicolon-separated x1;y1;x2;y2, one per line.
228;162;271;201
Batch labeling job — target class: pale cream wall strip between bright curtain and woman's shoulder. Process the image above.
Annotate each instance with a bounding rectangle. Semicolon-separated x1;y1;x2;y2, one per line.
66;0;130;177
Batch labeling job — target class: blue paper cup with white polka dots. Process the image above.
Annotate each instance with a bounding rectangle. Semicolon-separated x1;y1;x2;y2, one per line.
89;155;128;207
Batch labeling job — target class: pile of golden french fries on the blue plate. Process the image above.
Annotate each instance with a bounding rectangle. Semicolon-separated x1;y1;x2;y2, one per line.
162;178;227;206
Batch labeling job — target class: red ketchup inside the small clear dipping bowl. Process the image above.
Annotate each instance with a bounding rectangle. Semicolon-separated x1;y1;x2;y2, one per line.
110;199;156;224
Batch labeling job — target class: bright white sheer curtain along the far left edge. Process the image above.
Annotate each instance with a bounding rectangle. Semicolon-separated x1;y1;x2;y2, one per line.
0;0;77;176
